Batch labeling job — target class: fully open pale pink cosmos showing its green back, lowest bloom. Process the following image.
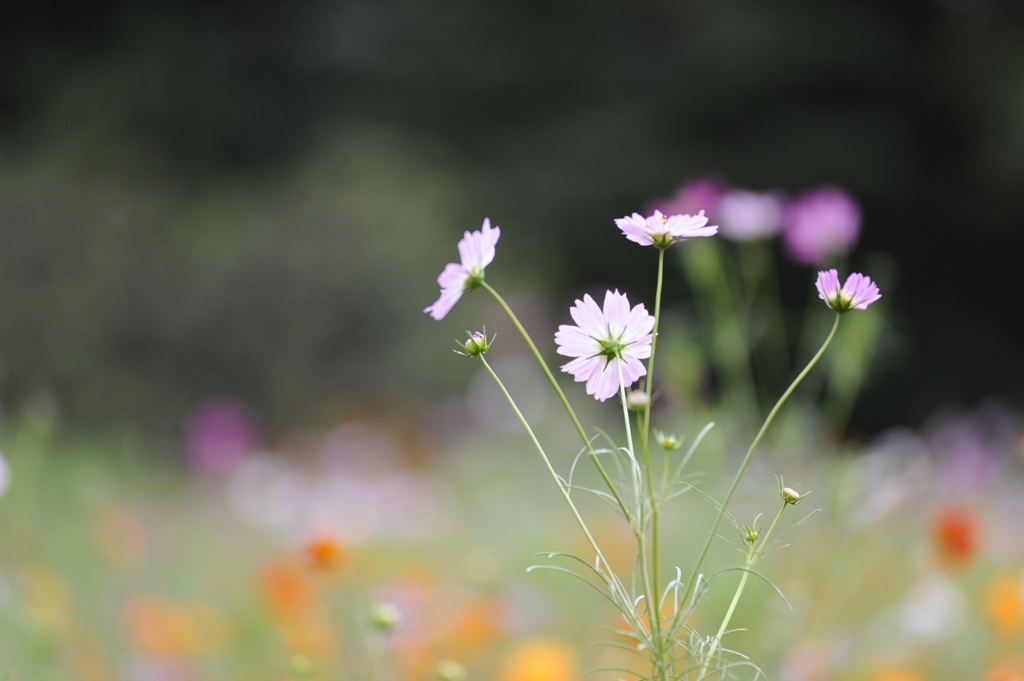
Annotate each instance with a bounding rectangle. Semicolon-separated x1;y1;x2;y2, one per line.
555;291;654;401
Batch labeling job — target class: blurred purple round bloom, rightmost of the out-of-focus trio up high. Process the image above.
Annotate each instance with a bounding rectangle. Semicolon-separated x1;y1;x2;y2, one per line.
782;187;860;265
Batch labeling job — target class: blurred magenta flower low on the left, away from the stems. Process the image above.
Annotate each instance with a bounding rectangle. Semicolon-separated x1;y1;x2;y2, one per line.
184;397;262;476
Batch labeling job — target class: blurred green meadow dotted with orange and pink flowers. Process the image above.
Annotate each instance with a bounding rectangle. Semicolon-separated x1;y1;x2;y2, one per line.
0;388;1024;681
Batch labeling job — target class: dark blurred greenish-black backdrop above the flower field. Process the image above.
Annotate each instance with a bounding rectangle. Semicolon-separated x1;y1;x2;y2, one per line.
0;0;1024;433
